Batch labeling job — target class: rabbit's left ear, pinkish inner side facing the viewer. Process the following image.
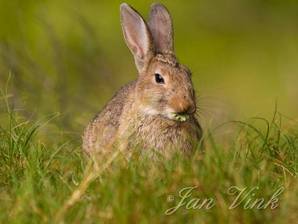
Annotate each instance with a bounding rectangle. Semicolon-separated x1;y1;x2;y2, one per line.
120;3;153;72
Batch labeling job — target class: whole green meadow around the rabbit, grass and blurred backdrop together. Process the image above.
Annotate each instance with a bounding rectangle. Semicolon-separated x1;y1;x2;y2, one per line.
0;0;298;223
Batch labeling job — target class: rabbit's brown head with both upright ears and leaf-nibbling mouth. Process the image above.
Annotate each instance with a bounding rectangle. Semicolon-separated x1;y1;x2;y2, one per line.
120;3;196;121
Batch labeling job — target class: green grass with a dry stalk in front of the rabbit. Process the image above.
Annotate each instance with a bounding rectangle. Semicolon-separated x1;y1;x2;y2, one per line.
0;91;298;223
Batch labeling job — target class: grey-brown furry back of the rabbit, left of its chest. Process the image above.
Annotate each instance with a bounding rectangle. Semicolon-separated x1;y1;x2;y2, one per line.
83;82;135;153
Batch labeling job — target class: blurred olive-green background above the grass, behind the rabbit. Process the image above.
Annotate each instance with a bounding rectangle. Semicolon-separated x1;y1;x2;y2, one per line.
0;0;298;140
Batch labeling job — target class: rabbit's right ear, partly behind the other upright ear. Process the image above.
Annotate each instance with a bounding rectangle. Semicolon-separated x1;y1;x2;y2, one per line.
148;3;174;53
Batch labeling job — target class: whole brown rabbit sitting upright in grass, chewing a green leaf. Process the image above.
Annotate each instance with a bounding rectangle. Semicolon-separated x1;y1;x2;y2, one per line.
83;3;202;157
